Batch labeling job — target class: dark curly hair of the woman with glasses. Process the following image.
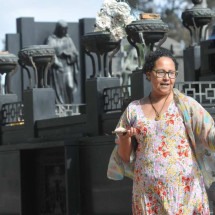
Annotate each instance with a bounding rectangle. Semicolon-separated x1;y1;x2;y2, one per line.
142;48;178;73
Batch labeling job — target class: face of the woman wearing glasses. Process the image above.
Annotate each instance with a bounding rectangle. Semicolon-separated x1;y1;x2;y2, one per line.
146;57;176;96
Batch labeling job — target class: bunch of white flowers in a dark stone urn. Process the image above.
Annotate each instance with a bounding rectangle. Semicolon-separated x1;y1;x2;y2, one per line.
94;0;136;41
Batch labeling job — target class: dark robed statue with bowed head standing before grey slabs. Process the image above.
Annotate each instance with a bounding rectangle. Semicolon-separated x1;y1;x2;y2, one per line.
47;20;79;104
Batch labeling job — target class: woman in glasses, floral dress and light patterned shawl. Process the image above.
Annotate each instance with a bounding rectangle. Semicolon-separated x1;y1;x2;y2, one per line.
108;49;215;215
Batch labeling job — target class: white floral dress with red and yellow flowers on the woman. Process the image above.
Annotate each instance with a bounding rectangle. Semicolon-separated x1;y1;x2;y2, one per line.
118;100;210;215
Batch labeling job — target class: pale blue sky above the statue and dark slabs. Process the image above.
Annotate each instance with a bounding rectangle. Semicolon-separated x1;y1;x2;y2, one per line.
0;0;103;51
